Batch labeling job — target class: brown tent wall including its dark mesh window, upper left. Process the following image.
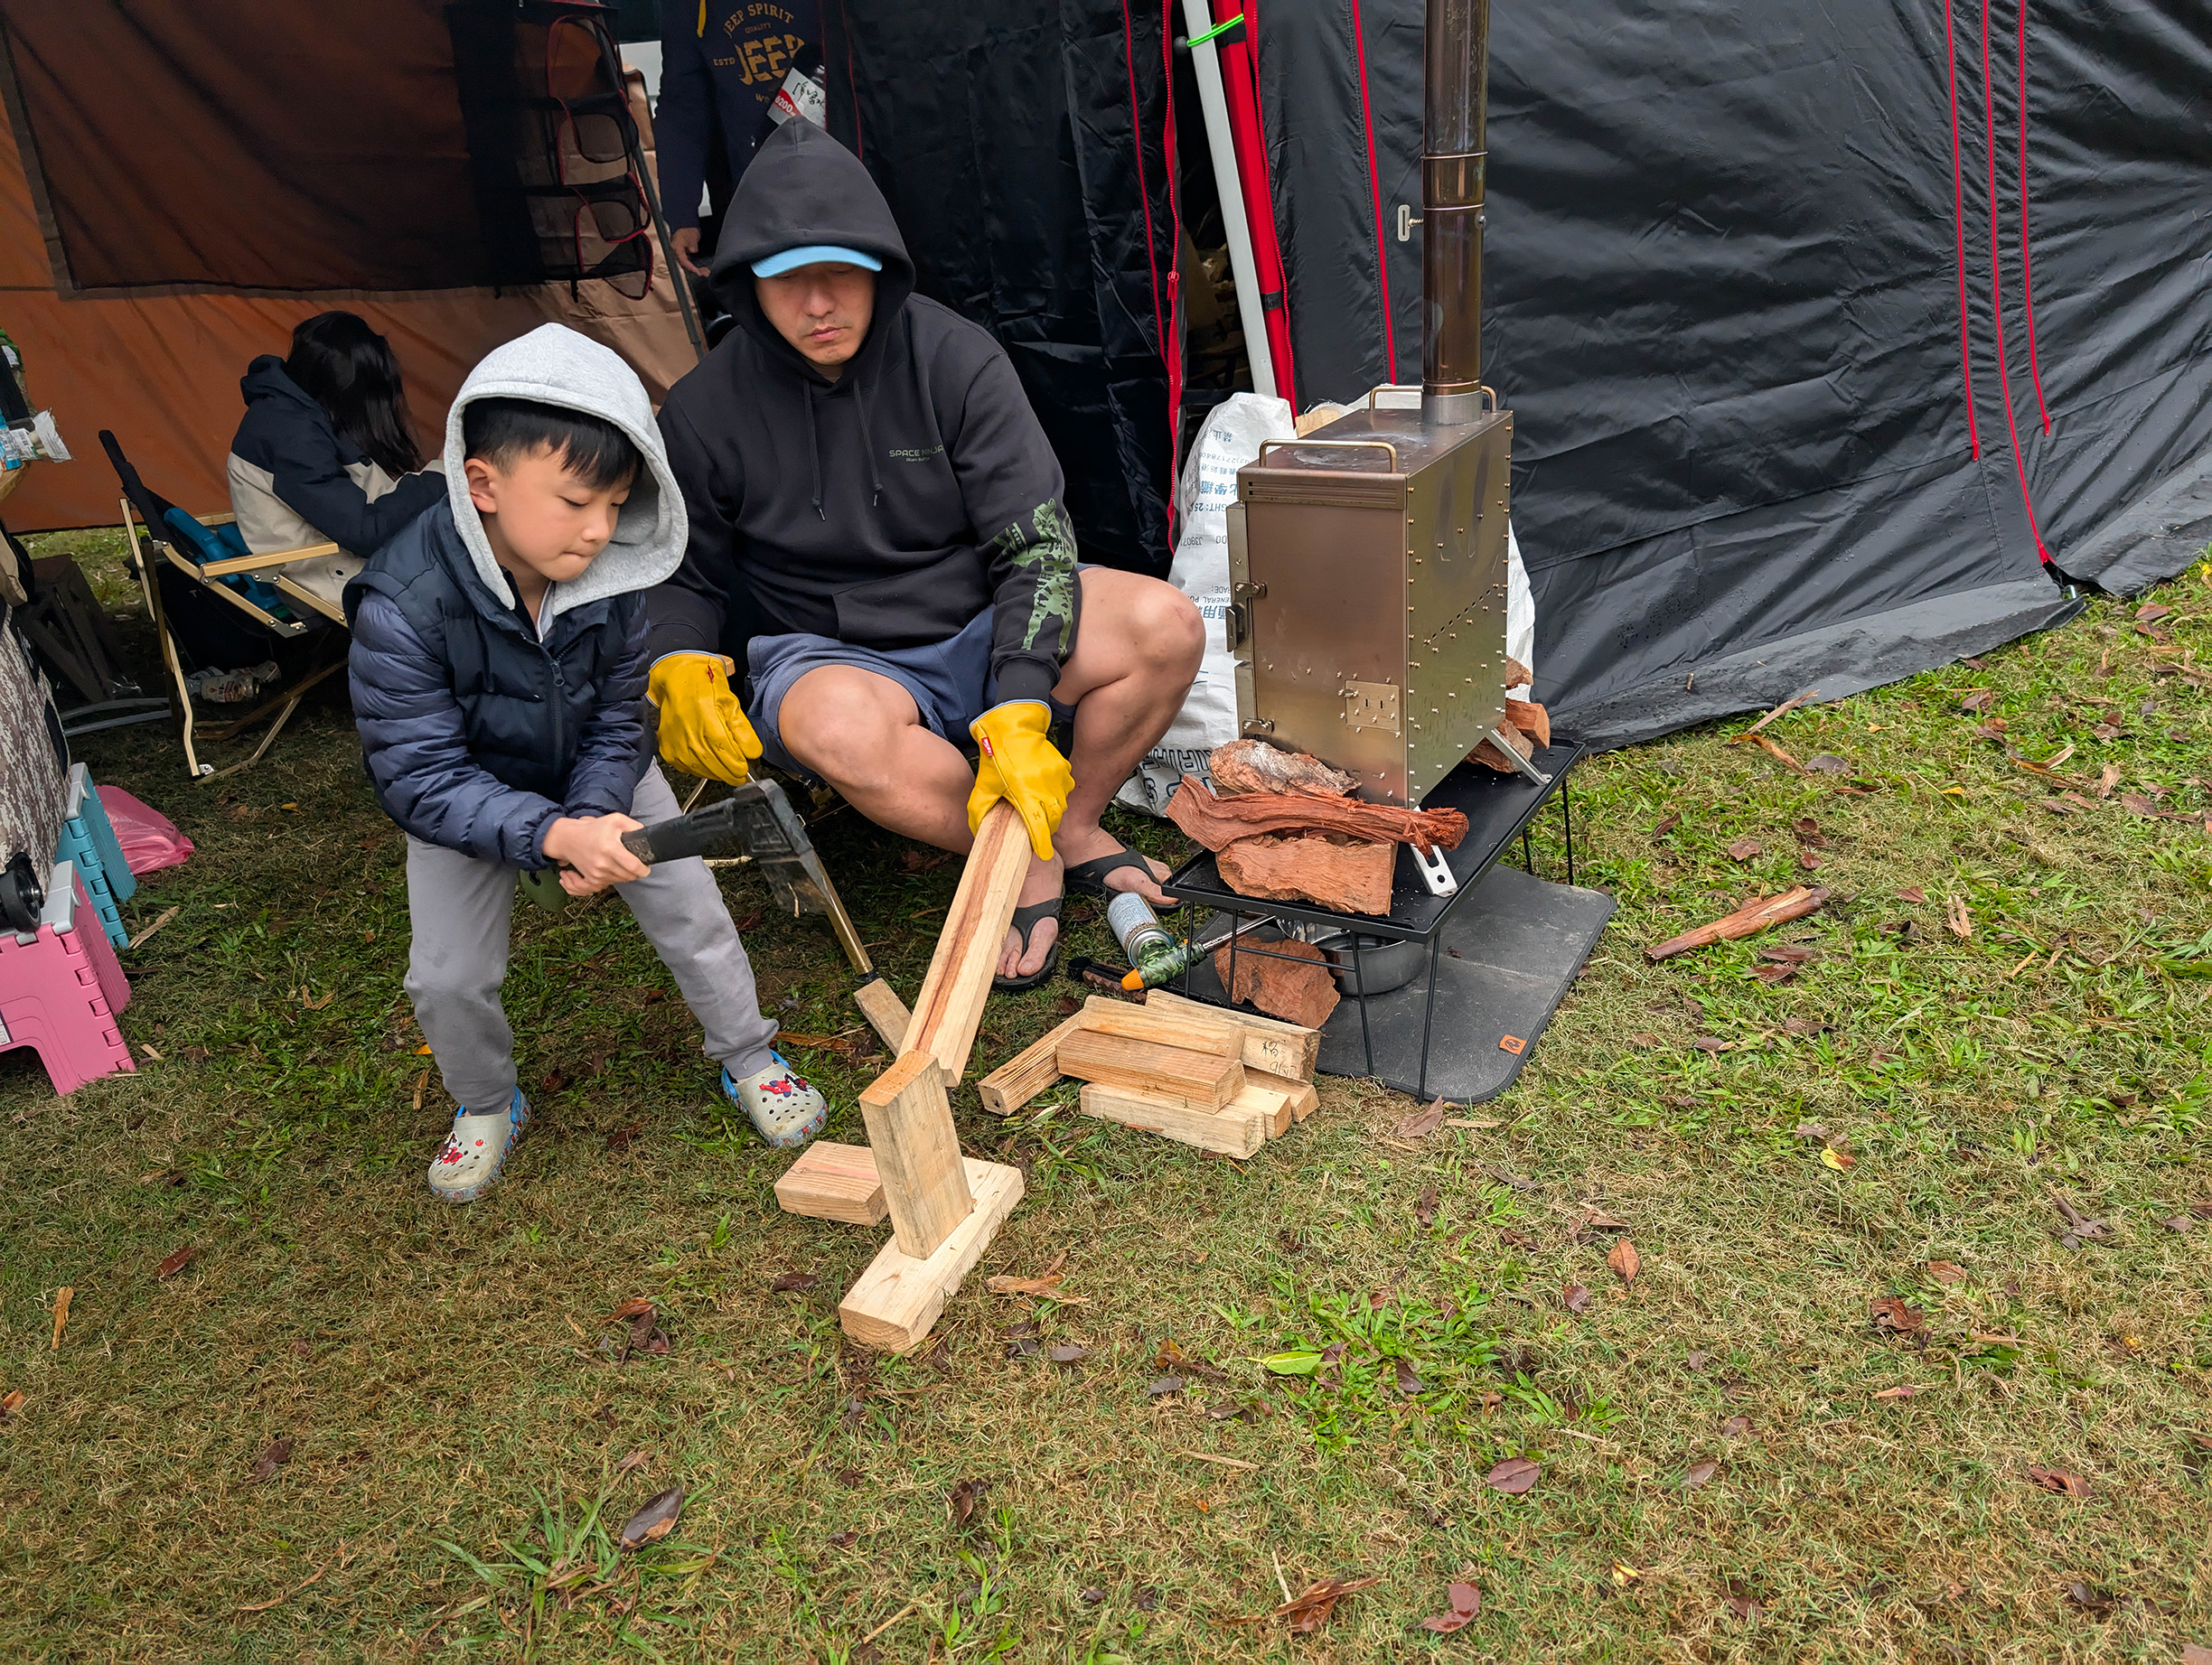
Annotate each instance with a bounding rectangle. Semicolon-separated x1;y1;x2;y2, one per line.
0;0;695;530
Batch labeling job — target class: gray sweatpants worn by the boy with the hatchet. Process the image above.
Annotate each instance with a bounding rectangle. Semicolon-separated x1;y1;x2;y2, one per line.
407;765;776;1115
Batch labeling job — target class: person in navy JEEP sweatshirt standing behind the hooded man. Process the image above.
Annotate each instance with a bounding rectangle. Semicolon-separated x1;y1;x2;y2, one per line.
652;0;823;276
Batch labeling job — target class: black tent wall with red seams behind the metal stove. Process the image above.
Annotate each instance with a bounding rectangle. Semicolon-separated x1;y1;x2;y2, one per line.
1256;0;2212;743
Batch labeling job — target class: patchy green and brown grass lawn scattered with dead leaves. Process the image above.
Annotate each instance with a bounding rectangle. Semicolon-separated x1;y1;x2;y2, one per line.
0;538;2212;1665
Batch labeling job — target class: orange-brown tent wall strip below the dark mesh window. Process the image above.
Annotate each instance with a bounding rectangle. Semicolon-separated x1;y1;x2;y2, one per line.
0;58;697;530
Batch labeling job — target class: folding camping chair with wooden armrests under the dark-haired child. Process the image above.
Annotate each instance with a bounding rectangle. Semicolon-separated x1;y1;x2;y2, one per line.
99;429;347;781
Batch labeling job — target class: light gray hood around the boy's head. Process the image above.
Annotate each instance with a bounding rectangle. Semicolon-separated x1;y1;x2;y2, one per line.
445;323;690;637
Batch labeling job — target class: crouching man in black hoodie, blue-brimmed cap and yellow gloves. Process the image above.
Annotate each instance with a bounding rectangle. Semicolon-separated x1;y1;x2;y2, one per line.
648;122;1204;988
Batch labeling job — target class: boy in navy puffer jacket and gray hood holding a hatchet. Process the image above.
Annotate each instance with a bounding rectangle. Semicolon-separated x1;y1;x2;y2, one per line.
345;323;828;1202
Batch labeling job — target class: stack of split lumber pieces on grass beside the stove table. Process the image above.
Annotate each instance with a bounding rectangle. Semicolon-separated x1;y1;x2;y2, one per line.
978;988;1320;1156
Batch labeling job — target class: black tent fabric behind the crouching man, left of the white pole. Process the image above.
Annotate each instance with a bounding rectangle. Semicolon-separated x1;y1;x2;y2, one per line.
823;0;1181;575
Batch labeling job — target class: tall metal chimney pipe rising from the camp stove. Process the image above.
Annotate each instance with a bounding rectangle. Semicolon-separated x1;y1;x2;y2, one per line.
1420;0;1491;426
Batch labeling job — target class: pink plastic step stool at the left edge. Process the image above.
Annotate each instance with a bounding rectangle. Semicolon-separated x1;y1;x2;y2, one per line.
0;863;137;1092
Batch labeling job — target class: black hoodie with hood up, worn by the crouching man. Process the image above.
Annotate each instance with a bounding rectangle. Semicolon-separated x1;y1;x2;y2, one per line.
646;122;1077;698
